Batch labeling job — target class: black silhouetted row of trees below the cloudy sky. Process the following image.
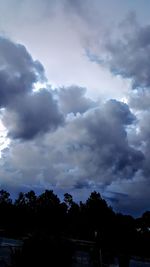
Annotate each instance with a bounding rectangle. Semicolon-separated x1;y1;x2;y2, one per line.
0;190;150;258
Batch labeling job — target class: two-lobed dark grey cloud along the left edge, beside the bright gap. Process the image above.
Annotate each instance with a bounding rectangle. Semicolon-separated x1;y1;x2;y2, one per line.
0;37;63;139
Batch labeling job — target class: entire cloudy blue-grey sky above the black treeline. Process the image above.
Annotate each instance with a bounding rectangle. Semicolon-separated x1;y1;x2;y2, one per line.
0;0;150;216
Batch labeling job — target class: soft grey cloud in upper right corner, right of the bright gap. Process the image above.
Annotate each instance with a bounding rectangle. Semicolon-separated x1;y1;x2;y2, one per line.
89;17;150;89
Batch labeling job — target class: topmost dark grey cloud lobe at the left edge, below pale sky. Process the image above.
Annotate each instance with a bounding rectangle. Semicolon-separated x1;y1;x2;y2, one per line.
0;37;45;107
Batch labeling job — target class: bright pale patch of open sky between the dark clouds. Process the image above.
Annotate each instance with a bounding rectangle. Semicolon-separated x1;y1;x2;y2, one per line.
0;0;135;102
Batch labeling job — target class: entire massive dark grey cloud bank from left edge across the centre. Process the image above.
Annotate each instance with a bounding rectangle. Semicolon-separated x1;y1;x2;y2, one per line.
0;35;148;216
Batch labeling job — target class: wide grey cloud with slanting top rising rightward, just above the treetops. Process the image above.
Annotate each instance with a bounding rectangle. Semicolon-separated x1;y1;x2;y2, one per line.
0;97;145;217
